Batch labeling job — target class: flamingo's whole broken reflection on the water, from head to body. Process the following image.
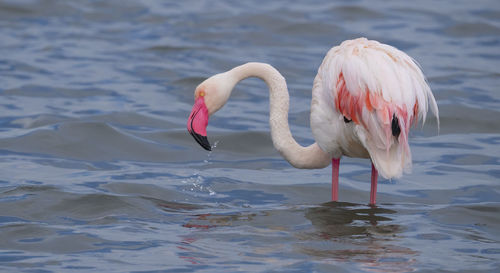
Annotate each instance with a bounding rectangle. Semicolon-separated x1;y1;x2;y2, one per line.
179;202;418;272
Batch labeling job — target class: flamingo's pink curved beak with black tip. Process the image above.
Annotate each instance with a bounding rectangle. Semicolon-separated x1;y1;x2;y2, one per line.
187;97;212;151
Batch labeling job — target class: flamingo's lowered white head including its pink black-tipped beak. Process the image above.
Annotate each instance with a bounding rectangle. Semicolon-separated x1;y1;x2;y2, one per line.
187;72;235;151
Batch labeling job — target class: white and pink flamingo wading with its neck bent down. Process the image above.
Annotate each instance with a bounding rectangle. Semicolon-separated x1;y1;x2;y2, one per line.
187;37;439;205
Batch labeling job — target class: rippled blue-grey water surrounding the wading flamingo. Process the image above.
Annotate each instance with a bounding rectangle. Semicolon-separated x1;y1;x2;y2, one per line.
0;0;500;272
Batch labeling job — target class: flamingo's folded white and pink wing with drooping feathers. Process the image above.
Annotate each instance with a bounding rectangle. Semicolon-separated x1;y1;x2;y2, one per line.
319;38;439;178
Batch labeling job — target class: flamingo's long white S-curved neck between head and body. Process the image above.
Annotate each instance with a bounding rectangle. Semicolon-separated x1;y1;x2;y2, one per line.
229;63;331;169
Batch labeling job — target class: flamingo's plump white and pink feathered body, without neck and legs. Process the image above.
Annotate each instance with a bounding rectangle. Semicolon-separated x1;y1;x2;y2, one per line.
311;38;438;178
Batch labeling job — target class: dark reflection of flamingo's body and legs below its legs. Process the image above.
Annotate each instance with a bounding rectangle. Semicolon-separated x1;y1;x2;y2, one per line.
300;202;417;272
